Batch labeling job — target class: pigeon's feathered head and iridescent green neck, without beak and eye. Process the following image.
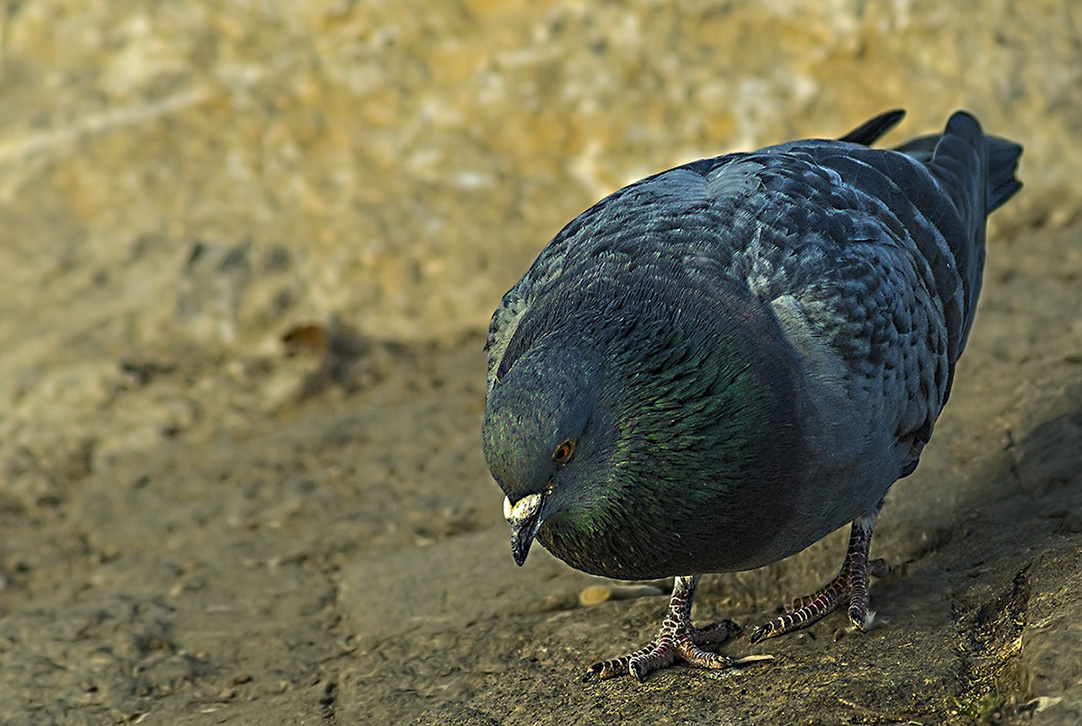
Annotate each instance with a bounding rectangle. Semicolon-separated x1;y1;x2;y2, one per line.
485;267;801;579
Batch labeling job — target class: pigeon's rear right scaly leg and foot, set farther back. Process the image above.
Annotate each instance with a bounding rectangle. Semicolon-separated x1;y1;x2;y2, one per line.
749;515;890;643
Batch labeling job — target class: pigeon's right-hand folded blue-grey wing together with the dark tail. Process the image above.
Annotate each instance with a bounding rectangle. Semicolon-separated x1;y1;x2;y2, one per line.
715;113;1020;467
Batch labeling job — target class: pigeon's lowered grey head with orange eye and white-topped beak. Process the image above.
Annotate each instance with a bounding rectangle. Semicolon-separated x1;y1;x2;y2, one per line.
483;340;615;565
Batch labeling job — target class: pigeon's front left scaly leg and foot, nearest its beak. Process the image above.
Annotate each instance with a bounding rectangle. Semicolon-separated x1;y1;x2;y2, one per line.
586;575;763;681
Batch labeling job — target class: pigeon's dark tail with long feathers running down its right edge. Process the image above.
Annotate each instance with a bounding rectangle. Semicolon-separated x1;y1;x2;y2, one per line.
895;111;1021;353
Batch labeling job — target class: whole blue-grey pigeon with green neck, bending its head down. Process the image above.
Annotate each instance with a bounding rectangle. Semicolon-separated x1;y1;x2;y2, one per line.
483;110;1021;681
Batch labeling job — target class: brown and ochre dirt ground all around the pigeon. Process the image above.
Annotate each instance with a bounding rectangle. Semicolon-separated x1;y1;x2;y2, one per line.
0;0;1082;726
